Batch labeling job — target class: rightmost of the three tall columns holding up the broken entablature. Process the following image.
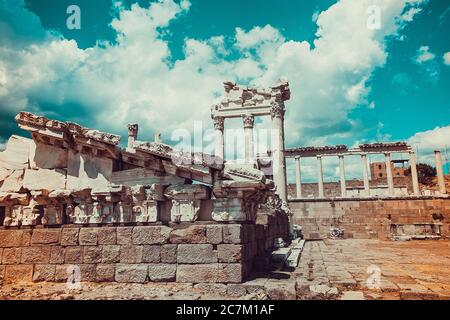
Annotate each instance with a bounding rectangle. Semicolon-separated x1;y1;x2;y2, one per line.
270;103;287;204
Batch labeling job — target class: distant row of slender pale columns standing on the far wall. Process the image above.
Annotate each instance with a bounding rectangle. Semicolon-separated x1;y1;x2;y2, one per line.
295;151;424;198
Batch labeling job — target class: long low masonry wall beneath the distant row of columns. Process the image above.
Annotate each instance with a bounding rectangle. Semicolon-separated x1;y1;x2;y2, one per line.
289;198;450;239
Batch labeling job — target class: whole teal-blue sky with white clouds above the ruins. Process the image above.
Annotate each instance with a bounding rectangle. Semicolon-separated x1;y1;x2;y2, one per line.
0;0;450;177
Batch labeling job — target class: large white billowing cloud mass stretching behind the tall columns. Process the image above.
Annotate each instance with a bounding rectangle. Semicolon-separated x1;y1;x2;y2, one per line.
0;0;429;180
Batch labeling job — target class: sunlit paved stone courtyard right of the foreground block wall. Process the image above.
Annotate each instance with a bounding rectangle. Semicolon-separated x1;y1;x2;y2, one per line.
294;239;450;299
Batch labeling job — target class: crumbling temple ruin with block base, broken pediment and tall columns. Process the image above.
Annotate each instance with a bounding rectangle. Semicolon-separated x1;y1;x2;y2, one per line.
0;82;289;283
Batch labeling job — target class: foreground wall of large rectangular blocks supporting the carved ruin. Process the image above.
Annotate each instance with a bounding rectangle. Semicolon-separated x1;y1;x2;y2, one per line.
0;216;288;283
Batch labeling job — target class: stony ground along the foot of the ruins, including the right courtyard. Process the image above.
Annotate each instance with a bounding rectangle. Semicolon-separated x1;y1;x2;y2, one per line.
0;239;450;300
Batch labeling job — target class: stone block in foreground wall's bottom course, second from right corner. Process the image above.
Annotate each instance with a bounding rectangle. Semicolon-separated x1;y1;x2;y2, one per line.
176;263;219;283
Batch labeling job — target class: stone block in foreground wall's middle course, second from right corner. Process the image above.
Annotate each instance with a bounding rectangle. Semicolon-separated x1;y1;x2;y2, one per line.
177;244;217;264
